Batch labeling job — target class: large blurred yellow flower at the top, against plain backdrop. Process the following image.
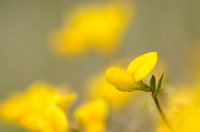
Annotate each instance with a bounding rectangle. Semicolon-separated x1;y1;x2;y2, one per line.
50;3;131;55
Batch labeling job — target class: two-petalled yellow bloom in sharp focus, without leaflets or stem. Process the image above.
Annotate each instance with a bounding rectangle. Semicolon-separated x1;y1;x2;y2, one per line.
105;52;157;92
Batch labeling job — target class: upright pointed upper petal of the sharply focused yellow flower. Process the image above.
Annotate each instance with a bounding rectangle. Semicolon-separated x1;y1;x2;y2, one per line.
127;52;157;82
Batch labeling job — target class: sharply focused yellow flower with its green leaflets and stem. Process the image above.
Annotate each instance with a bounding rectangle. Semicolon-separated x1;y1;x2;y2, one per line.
105;52;173;131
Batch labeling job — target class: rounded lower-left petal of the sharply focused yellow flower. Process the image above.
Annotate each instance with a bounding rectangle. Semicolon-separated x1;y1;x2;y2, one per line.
105;67;135;92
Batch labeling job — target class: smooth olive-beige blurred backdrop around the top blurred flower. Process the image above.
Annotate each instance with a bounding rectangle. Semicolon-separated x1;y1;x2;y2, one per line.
0;0;200;132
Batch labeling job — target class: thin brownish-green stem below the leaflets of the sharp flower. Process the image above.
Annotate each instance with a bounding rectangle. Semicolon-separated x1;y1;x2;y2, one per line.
152;91;174;132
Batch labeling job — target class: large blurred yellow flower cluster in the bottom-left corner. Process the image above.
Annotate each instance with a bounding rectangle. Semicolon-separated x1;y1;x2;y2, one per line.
0;82;76;132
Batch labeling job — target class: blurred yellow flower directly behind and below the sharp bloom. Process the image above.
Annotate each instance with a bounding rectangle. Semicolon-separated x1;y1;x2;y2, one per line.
87;73;134;110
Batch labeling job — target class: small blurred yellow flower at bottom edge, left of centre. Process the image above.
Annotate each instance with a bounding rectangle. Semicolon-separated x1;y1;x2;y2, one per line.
75;99;108;132
